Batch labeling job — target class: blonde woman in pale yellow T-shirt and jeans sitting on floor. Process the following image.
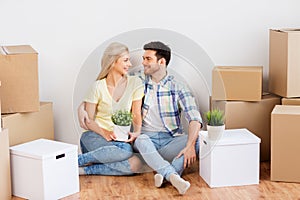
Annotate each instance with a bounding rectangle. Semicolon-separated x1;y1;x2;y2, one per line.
78;42;144;175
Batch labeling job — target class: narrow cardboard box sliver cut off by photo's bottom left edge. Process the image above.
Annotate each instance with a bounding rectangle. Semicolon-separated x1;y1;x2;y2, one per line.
0;128;11;200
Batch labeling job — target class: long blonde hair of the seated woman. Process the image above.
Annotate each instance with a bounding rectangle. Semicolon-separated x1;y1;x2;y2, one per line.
97;42;129;80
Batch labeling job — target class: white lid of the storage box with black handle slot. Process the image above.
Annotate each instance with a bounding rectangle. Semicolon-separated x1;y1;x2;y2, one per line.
10;139;77;160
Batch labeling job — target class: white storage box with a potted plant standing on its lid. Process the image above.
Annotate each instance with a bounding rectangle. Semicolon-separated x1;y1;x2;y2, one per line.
199;129;260;187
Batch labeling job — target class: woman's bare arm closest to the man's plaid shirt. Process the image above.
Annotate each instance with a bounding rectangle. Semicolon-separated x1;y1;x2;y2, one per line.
127;100;142;142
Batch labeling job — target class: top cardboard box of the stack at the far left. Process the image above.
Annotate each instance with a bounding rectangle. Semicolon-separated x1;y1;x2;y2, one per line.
0;45;39;113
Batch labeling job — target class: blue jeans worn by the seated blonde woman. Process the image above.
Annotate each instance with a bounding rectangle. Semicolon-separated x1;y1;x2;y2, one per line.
78;131;133;175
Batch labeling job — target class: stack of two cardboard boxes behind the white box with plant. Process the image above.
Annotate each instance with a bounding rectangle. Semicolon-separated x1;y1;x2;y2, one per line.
211;66;280;161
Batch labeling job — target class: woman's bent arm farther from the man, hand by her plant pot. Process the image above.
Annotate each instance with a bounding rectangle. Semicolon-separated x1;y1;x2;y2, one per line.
85;102;116;141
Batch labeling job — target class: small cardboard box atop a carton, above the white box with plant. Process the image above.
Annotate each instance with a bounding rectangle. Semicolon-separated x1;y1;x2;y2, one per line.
212;66;262;101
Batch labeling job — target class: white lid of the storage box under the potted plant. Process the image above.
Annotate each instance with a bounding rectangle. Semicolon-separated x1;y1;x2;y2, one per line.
200;128;261;146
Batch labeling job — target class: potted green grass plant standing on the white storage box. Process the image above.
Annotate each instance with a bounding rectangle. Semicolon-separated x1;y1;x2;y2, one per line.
205;108;225;140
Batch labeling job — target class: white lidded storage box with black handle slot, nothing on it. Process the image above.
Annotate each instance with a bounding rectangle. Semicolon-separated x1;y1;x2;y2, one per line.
10;139;79;200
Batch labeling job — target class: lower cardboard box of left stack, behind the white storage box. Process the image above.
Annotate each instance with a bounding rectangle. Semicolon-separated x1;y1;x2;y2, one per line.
2;102;54;146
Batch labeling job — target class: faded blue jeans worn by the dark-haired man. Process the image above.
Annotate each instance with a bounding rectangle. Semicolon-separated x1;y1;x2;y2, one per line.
134;132;199;181
